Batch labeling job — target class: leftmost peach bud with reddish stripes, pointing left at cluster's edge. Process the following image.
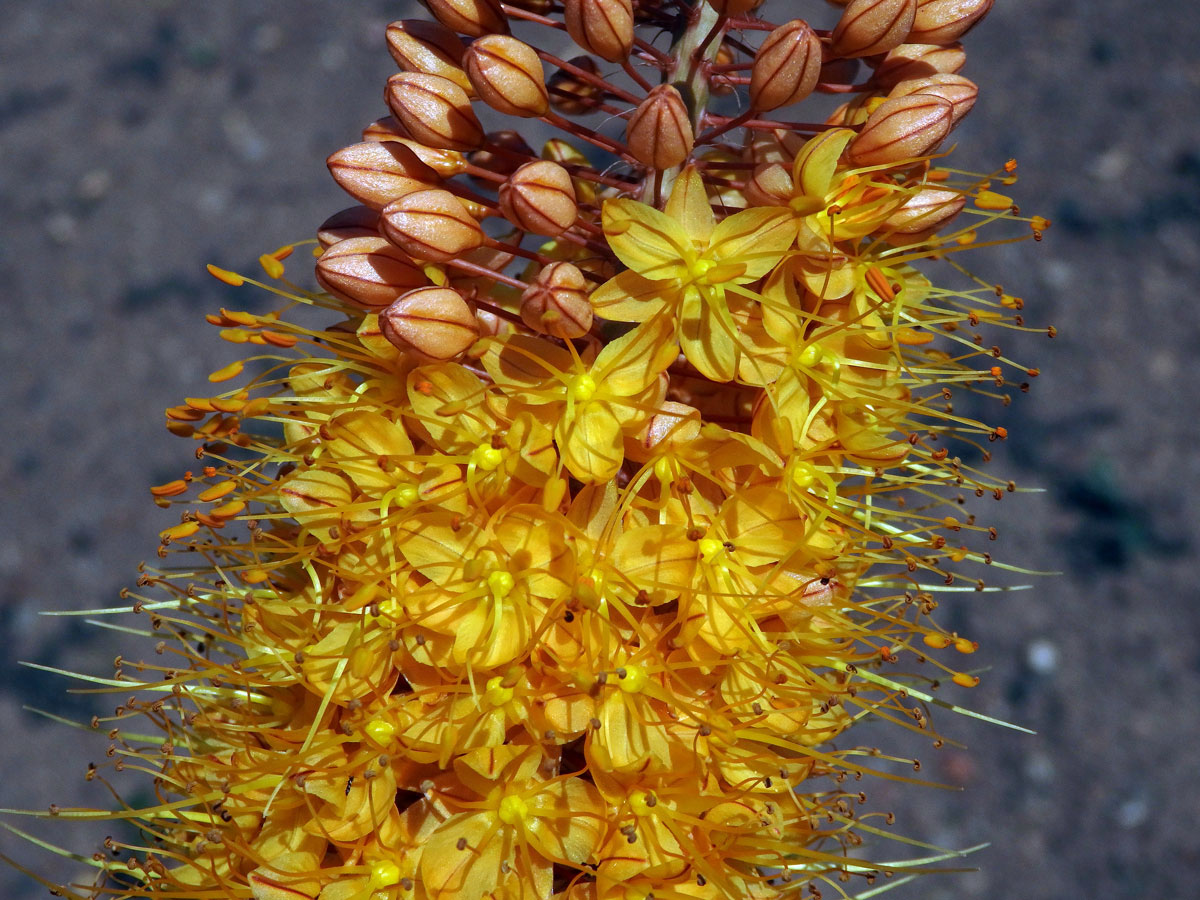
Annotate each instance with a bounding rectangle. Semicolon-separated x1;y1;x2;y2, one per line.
317;234;430;310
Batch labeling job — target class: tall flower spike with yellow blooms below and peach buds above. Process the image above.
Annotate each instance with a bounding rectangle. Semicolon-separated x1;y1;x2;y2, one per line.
14;0;1048;900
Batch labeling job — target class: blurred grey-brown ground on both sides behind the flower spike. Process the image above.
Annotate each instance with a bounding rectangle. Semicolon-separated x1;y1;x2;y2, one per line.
0;0;1200;900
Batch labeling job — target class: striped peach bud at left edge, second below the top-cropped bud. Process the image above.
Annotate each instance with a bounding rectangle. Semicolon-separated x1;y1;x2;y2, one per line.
384;72;484;150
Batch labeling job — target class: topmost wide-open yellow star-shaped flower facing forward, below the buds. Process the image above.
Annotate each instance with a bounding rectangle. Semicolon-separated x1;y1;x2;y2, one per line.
592;168;796;382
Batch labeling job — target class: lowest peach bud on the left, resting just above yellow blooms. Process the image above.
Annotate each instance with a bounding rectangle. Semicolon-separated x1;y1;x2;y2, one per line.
379;287;479;362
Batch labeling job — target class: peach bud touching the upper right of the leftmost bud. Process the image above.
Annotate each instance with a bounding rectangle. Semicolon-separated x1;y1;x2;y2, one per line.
379;191;484;263
